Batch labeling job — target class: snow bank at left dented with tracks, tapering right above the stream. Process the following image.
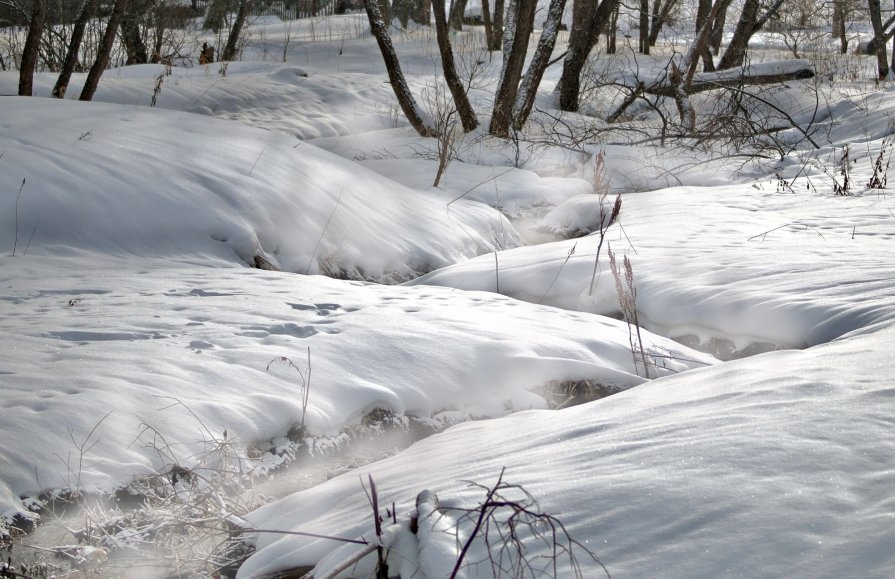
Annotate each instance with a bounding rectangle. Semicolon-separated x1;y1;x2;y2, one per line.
0;255;713;515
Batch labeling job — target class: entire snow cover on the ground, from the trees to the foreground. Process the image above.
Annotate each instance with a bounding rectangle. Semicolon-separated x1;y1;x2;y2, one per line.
0;11;895;578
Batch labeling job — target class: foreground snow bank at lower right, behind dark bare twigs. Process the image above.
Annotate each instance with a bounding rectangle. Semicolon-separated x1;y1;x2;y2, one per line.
239;328;895;578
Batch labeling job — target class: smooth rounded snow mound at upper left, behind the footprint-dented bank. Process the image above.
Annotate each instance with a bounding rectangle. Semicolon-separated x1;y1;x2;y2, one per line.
0;98;519;281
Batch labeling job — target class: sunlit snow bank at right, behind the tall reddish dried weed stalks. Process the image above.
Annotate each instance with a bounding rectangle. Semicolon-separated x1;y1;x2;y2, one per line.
410;180;895;358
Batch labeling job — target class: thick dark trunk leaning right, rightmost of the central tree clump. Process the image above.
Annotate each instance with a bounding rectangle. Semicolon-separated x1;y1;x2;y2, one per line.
559;0;619;111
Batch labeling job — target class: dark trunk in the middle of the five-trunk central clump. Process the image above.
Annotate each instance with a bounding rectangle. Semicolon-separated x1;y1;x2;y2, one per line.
488;0;537;138
